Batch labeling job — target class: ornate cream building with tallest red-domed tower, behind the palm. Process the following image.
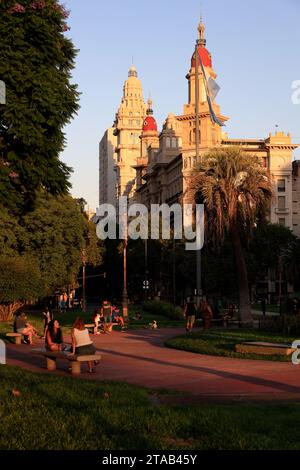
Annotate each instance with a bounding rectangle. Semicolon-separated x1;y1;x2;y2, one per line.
136;21;300;236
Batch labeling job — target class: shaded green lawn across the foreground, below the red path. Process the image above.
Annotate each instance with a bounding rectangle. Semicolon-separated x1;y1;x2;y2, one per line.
0;366;300;450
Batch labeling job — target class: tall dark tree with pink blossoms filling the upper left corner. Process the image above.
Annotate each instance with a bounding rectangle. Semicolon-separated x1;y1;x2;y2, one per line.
0;0;79;210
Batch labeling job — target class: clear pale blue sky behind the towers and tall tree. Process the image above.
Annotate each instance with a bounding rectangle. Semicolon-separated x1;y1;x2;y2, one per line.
61;0;300;209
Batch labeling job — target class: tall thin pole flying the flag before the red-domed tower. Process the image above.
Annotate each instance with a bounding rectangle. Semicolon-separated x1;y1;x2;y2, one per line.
195;39;202;307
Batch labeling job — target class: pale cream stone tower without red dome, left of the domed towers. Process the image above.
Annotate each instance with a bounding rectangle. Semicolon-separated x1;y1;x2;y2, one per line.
114;65;146;198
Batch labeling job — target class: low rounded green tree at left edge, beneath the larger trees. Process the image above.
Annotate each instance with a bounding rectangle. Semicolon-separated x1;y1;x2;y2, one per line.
0;256;45;321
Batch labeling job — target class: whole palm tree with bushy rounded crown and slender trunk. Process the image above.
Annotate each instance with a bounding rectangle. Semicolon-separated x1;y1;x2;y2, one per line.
187;147;272;326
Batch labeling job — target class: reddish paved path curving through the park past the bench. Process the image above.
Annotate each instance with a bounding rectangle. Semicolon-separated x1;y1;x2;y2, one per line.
7;328;300;401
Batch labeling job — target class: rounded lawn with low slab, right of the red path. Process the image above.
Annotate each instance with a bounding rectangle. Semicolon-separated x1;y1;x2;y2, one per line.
165;329;295;361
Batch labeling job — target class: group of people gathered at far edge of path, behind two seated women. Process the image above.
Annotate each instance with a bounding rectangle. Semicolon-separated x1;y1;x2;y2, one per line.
93;300;125;335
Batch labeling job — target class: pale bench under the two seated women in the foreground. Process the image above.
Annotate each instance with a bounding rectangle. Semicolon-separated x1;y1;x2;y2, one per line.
32;348;101;375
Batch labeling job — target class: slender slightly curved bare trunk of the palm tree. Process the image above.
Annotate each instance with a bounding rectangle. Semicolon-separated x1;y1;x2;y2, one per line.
231;227;253;327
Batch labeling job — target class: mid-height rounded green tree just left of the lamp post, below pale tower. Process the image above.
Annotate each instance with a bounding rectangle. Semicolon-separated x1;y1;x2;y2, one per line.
20;193;101;293
